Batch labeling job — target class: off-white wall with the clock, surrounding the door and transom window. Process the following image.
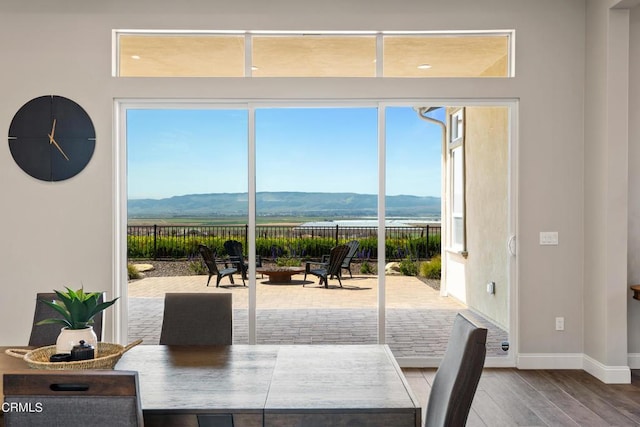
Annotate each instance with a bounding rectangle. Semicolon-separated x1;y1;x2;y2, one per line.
0;0;626;374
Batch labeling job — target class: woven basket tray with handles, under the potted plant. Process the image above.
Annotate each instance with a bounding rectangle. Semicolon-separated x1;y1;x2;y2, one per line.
5;340;142;371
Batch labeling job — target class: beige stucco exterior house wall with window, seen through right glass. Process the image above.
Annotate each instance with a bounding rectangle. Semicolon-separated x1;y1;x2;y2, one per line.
443;106;512;363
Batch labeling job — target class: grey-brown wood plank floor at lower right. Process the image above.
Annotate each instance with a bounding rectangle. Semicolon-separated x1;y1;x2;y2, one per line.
403;368;640;427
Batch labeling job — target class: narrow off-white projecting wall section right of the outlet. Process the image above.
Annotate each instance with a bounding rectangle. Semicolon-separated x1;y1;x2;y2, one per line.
583;0;629;379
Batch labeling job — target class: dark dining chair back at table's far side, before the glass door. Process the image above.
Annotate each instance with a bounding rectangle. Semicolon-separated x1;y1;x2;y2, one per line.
160;292;233;345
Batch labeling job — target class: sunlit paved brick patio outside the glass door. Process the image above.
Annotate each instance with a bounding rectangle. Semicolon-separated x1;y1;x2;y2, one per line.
128;275;508;357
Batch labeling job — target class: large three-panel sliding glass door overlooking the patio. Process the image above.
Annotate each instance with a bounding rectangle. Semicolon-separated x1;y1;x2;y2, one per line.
120;102;514;366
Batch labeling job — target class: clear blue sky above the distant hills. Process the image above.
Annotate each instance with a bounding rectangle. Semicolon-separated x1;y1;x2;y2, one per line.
127;107;443;199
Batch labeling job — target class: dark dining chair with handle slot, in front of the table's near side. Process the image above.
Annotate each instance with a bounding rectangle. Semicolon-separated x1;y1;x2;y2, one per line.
2;370;144;427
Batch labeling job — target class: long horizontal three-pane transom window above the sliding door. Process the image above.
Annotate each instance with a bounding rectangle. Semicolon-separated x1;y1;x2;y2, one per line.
113;30;514;78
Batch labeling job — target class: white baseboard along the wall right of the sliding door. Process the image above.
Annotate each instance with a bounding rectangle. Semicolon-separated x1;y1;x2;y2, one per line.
516;353;640;384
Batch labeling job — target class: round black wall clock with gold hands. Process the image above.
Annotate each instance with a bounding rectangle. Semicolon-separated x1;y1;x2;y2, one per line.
9;95;96;181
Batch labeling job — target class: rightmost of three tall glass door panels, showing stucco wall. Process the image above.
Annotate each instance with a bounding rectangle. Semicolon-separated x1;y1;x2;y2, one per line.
385;106;510;364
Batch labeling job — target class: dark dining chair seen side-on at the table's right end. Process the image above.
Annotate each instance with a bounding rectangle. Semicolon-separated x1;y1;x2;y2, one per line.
424;313;487;427
